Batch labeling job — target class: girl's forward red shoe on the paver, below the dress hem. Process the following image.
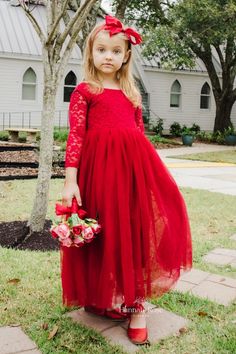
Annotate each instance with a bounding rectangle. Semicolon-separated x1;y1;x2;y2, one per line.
127;303;149;344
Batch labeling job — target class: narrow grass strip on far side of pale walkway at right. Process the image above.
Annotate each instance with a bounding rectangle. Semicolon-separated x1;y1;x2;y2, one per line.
170;150;236;164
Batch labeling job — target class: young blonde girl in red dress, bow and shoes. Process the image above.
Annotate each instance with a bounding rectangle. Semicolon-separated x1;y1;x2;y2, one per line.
61;16;192;344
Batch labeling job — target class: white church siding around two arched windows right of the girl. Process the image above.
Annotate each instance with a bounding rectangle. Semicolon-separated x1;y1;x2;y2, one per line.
145;70;215;130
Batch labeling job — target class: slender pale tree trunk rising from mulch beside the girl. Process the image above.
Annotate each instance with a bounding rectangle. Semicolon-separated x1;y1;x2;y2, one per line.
28;70;57;233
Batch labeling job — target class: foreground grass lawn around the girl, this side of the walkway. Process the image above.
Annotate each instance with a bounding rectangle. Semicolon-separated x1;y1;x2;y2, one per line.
0;180;236;354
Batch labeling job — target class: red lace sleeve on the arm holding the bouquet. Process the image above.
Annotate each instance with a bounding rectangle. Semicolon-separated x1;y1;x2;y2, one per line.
65;90;87;168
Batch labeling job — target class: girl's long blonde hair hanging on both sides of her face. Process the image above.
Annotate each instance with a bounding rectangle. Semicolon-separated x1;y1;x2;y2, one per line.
84;24;141;107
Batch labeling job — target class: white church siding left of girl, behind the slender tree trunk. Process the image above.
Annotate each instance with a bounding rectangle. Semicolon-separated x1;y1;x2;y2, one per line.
0;57;82;130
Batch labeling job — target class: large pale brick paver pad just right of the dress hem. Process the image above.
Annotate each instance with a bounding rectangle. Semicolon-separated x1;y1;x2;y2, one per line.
174;269;236;306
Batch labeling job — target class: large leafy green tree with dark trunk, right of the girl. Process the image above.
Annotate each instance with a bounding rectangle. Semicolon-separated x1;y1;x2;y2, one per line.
113;0;236;131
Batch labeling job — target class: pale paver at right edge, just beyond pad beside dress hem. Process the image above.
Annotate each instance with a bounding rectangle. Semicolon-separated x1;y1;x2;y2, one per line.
203;248;236;267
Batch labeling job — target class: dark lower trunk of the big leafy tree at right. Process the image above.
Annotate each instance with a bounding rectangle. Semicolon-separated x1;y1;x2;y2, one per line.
214;98;235;132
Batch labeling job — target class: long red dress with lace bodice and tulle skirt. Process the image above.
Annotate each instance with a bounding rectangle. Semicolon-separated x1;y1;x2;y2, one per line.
61;83;192;308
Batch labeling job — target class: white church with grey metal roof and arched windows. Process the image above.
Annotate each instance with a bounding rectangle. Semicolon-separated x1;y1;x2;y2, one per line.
0;0;236;131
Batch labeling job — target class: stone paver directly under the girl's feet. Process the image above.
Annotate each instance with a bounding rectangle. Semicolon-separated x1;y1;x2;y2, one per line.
68;303;188;353
